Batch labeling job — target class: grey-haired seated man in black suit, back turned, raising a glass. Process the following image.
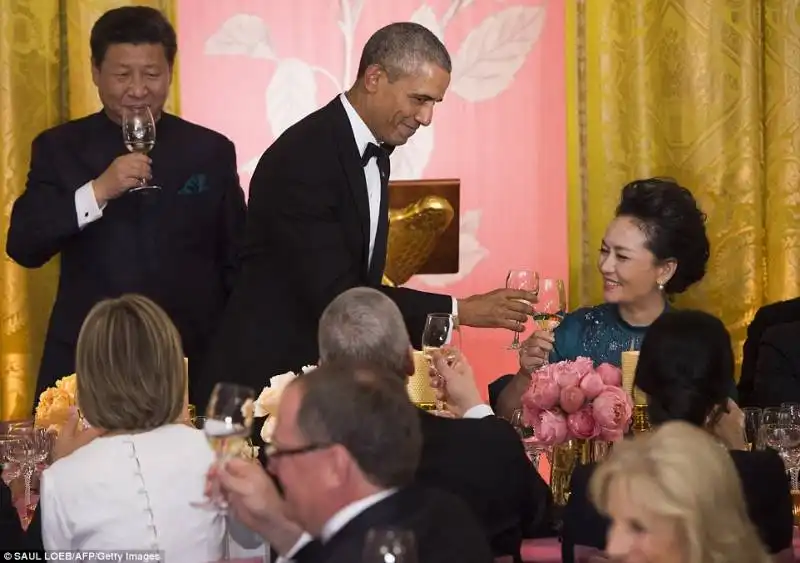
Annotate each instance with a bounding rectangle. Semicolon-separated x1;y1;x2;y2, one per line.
319;288;552;557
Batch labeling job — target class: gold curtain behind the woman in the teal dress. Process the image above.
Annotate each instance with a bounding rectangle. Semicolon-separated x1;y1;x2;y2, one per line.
567;0;800;370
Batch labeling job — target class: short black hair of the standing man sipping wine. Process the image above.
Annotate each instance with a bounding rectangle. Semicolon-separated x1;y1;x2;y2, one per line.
89;6;178;68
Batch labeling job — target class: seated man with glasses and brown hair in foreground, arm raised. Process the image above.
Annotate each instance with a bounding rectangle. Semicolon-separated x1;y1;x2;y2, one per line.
216;363;492;563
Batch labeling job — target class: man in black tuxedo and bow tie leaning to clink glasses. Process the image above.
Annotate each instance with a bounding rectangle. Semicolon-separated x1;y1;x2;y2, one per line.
198;23;535;410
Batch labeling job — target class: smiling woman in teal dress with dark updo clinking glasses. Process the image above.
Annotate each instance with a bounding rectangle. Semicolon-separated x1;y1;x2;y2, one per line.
489;178;709;418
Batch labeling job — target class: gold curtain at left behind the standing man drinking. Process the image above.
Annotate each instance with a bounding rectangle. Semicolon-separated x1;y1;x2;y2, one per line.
0;0;178;420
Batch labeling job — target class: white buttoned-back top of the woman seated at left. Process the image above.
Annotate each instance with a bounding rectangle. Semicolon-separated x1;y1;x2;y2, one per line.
40;424;224;563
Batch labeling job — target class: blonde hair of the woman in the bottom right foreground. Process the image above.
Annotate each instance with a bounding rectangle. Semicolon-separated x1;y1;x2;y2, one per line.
589;421;772;563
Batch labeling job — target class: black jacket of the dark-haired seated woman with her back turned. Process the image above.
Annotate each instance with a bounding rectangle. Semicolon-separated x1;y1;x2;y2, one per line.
561;450;794;563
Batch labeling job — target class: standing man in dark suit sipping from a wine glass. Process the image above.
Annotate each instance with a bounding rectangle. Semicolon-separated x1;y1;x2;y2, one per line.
6;6;245;400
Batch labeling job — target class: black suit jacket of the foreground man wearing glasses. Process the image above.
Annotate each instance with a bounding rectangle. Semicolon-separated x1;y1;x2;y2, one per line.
293;487;493;563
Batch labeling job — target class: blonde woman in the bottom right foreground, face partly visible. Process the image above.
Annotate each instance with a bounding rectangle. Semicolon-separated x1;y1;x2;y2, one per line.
589;421;774;563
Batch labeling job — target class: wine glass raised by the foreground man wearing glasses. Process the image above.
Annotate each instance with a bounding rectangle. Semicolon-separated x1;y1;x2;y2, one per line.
192;383;256;513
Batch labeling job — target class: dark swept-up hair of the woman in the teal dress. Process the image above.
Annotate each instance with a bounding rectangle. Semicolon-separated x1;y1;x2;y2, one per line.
617;178;710;295
